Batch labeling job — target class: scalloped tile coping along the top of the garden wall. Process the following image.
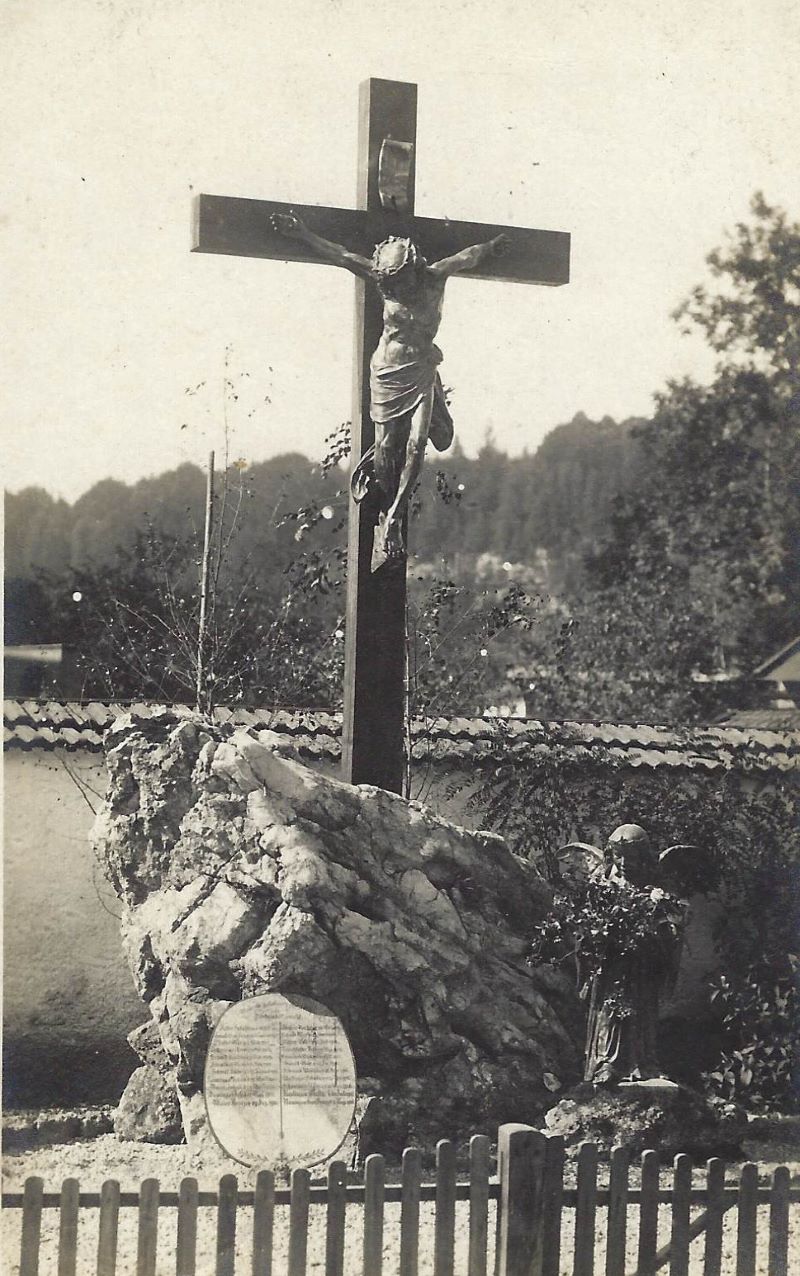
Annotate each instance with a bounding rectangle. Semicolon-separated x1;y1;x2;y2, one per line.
4;701;800;771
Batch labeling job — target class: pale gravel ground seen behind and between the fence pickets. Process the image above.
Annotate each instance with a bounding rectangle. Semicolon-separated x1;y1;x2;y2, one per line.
3;1134;800;1276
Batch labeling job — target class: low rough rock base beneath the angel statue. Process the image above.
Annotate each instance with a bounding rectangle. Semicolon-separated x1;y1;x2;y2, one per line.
544;1085;748;1162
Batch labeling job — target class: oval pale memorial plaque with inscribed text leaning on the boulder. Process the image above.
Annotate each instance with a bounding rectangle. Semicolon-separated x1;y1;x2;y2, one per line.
203;993;356;1169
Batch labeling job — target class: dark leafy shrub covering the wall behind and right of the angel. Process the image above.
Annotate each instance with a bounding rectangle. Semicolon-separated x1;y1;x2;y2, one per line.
473;745;800;1111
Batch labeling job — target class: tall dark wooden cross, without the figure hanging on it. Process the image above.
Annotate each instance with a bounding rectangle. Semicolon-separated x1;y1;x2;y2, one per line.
193;79;569;792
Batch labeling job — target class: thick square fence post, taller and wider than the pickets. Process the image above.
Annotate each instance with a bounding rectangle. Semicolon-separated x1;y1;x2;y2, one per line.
495;1124;547;1276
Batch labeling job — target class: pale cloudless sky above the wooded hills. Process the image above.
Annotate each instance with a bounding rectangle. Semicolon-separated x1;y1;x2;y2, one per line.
0;0;800;500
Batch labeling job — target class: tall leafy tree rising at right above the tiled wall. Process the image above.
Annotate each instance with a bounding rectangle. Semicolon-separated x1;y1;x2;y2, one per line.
538;195;800;721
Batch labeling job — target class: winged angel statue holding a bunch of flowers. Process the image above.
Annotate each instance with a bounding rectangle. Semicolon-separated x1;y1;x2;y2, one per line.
548;824;713;1086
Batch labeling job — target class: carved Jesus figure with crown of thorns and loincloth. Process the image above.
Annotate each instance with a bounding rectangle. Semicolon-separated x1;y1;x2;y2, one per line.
270;213;508;572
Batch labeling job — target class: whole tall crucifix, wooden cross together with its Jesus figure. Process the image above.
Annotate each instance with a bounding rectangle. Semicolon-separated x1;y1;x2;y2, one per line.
193;79;569;792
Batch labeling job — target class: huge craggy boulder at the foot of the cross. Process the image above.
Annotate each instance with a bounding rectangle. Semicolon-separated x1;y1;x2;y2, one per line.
94;712;579;1142
